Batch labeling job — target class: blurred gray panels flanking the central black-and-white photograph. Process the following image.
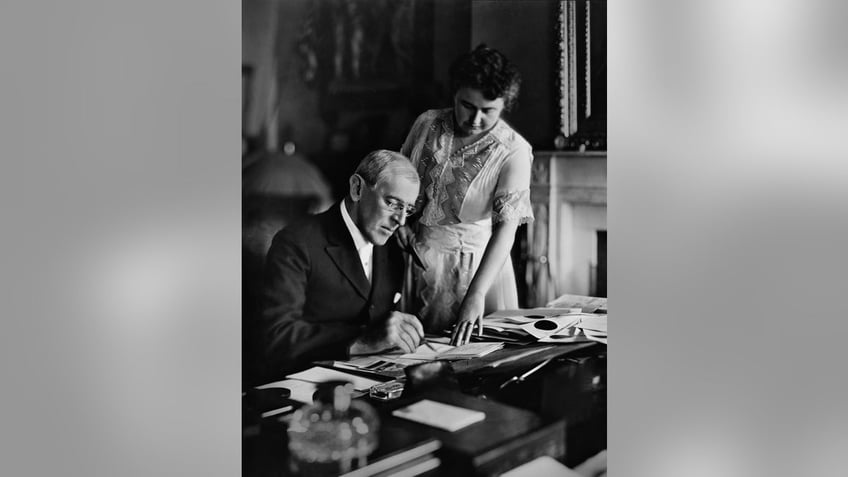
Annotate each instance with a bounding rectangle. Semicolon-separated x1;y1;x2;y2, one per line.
0;0;848;476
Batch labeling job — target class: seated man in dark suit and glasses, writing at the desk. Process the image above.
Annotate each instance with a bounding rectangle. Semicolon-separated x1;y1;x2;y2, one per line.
263;150;424;378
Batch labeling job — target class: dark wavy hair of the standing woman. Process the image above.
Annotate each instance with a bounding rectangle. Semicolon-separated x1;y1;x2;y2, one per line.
449;43;521;111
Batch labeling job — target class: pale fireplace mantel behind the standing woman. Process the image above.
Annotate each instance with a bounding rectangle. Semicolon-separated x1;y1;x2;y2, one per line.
526;151;607;306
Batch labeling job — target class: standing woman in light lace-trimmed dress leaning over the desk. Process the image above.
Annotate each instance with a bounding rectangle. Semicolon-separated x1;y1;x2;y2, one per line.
398;45;533;344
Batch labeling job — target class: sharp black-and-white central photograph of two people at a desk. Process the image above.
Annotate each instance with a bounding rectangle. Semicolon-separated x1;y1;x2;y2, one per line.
241;0;608;476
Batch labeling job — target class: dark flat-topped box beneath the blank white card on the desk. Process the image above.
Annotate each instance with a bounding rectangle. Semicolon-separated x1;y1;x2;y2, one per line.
383;388;565;475
